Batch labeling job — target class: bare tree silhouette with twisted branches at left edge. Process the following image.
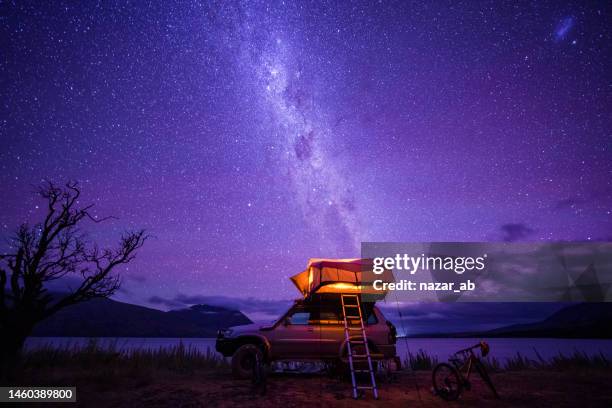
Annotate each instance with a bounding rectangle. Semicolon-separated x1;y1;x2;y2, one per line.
0;182;147;378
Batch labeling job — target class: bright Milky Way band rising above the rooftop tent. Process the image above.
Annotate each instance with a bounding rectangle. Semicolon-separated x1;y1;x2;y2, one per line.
252;26;361;253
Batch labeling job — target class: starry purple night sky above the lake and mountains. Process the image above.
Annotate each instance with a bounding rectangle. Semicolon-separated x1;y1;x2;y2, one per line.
0;1;612;309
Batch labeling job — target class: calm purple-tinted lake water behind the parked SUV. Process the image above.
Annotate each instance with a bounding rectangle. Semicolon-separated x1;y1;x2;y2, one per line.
26;337;612;361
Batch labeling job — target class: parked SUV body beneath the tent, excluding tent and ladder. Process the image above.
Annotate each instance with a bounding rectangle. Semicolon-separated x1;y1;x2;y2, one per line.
216;294;397;378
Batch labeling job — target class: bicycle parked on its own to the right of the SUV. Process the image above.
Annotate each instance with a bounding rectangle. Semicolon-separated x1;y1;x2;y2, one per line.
432;341;499;401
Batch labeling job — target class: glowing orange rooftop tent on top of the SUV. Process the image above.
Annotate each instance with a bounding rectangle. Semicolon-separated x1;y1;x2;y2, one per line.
291;258;394;300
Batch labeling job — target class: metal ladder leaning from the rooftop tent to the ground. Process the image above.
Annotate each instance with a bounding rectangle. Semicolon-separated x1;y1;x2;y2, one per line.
340;294;378;399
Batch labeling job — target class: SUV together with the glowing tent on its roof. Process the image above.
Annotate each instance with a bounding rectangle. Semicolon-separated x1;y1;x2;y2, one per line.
216;259;397;378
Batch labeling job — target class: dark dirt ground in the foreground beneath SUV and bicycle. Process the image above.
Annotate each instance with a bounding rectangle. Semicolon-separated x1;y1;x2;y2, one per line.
32;370;612;408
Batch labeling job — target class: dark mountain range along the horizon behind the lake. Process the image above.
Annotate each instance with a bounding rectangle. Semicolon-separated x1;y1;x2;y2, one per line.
32;299;612;338
